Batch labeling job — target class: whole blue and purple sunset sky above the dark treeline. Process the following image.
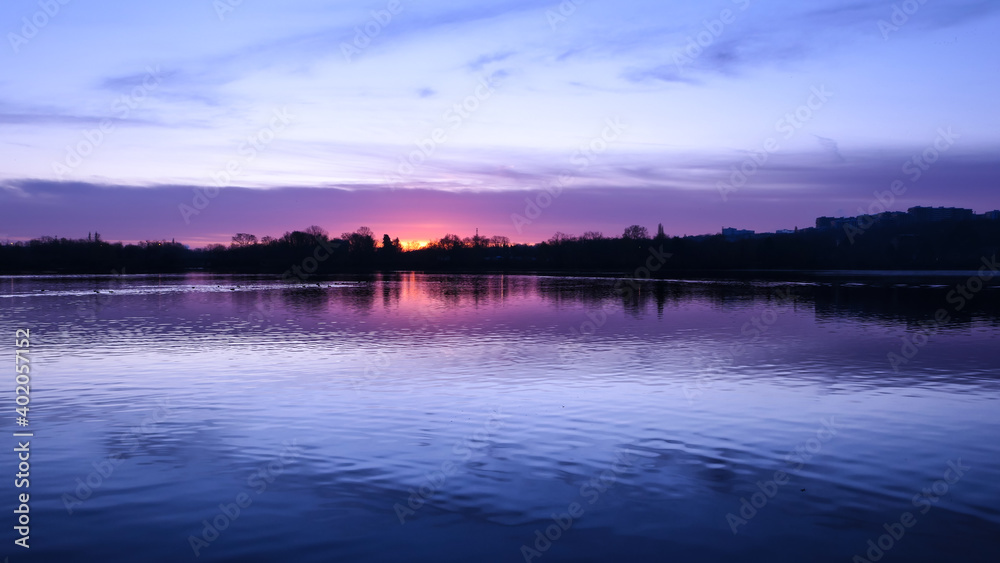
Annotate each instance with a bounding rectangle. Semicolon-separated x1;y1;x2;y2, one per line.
0;0;1000;246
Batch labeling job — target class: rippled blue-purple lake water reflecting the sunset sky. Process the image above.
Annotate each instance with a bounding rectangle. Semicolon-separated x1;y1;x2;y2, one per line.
0;273;1000;562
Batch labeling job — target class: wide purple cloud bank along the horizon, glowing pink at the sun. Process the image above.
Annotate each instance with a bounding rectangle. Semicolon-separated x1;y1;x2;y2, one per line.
0;150;1000;244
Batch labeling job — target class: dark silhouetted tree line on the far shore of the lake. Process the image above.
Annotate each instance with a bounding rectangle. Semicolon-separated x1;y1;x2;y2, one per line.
0;220;1000;279
